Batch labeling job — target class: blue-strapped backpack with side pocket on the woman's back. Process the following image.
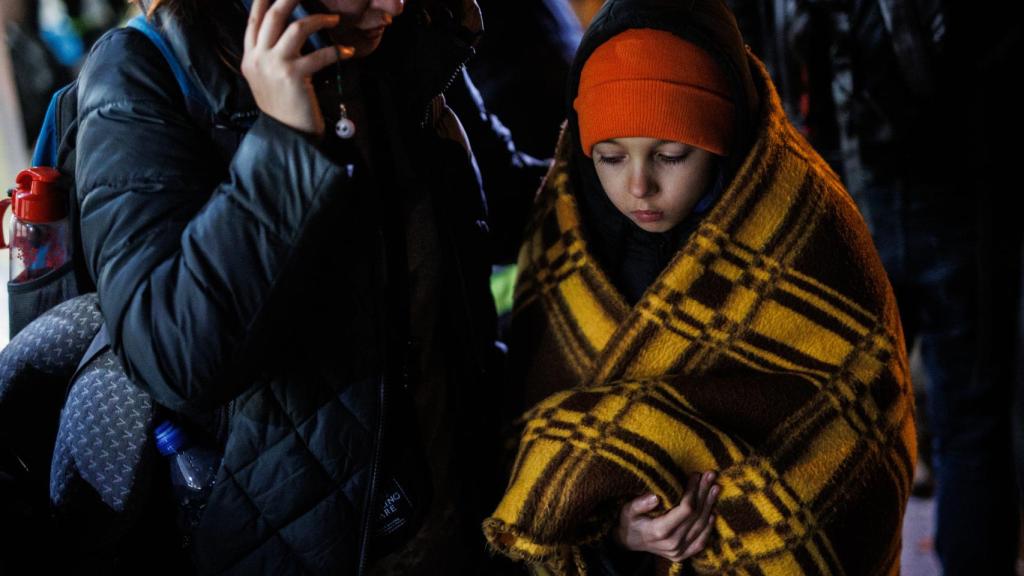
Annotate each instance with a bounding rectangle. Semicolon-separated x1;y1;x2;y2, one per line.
7;15;209;339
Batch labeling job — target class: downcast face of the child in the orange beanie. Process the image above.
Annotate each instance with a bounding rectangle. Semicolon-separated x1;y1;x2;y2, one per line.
592;137;716;232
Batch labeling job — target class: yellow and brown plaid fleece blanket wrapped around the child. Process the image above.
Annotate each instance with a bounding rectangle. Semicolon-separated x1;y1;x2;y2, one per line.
484;50;915;576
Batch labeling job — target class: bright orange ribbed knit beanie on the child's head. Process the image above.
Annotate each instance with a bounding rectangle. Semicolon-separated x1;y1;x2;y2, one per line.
572;29;734;157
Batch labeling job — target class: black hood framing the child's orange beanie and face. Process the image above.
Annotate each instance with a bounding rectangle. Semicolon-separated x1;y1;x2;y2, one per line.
566;0;760;302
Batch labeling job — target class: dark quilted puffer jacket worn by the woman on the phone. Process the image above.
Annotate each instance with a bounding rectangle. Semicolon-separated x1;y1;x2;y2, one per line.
77;0;543;574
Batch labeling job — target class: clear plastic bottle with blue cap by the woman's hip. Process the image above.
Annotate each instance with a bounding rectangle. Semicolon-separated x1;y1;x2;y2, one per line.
154;421;221;545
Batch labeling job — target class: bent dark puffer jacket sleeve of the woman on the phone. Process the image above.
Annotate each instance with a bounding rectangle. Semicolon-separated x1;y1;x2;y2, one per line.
76;30;348;412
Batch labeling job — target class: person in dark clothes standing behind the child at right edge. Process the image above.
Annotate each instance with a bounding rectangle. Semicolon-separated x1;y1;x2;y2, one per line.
800;0;1024;576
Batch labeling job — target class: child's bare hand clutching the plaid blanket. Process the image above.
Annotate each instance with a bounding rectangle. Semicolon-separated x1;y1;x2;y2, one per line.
614;471;721;562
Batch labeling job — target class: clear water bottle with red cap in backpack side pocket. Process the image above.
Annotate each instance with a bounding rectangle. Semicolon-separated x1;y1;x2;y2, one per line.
0;166;71;283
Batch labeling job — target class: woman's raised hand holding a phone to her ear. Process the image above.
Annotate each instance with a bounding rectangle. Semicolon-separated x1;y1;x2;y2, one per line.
242;0;354;135
